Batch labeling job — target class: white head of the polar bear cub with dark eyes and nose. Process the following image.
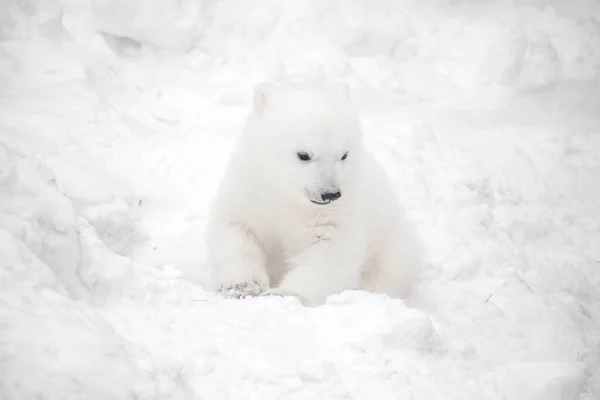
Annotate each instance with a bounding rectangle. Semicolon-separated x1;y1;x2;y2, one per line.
246;83;362;207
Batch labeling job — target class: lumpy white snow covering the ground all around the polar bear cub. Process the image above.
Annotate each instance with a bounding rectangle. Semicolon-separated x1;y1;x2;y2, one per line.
0;0;600;400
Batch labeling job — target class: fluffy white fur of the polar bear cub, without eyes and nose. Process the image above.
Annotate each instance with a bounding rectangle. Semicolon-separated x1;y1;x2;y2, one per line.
206;83;418;305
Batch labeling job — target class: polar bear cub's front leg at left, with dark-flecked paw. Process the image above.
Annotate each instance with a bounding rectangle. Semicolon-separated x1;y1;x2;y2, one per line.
207;223;269;298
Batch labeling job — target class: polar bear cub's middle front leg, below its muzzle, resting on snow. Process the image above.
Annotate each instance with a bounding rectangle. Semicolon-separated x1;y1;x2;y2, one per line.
264;240;364;306
